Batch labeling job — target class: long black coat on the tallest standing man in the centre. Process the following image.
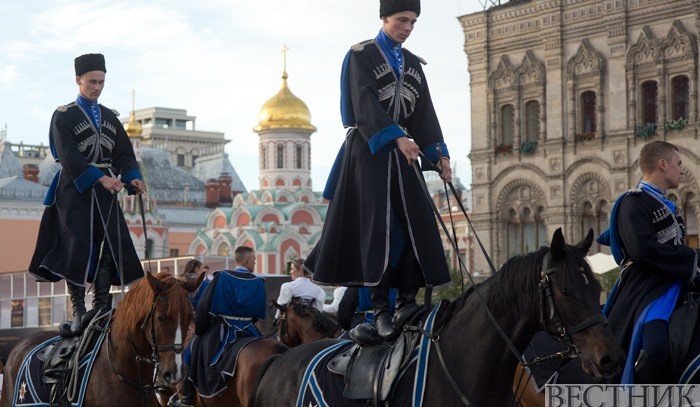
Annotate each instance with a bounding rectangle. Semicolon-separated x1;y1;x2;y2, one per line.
305;40;450;286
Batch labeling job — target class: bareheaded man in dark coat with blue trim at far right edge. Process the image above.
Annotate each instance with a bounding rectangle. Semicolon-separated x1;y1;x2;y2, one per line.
598;140;700;383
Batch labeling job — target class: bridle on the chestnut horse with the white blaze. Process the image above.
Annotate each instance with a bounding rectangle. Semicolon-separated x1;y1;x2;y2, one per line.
107;282;185;401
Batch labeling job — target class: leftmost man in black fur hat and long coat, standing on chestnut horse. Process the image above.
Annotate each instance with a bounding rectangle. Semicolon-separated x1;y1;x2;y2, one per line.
29;54;146;334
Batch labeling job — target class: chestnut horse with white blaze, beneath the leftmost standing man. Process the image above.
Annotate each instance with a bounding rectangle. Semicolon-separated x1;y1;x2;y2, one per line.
0;273;201;407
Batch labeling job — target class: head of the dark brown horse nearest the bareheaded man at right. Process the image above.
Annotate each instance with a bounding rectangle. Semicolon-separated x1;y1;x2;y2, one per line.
539;228;625;377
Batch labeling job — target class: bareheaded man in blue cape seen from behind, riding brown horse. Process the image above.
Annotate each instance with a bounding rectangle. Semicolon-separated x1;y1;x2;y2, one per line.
168;246;267;406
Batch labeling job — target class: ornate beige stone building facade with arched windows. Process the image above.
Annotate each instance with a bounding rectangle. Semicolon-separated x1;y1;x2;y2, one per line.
460;0;700;272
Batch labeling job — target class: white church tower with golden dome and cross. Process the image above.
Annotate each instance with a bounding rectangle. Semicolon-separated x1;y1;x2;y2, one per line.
253;45;316;190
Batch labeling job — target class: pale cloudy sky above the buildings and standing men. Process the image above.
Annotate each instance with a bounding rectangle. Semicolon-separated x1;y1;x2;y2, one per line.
0;0;481;190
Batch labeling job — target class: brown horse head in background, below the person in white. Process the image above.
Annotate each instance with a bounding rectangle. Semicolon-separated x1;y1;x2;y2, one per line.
272;297;341;348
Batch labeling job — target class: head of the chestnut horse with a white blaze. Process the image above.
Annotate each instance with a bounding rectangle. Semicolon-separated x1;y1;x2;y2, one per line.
142;273;204;387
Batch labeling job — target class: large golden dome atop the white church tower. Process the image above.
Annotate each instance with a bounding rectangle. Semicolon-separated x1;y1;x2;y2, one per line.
253;72;316;133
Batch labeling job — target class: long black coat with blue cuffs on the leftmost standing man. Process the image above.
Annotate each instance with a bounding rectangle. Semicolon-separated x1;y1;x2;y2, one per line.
29;103;144;286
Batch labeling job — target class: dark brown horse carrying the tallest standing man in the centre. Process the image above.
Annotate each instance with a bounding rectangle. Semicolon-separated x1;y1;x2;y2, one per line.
254;229;624;407
